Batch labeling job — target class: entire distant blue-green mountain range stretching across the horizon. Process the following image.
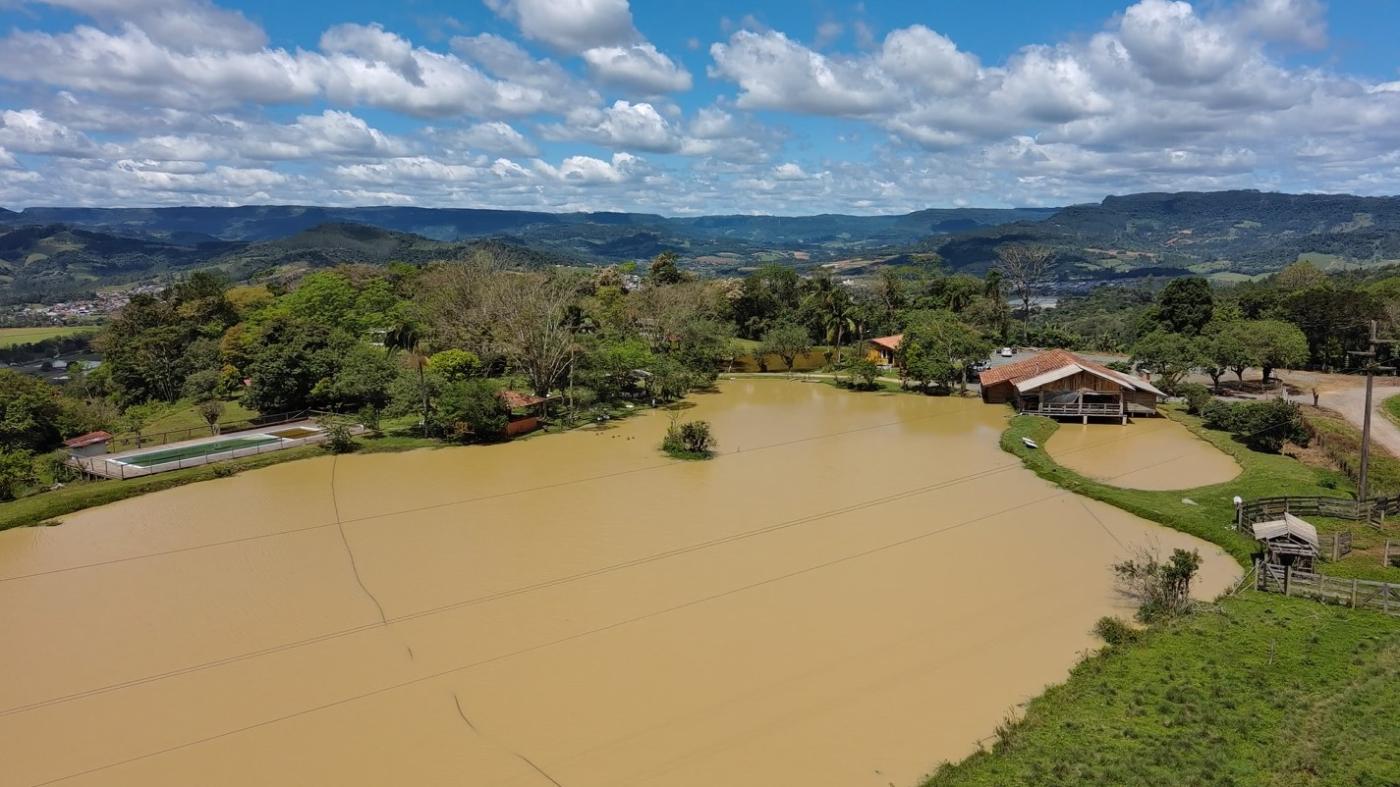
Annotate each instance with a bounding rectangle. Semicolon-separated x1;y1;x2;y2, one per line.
0;190;1400;302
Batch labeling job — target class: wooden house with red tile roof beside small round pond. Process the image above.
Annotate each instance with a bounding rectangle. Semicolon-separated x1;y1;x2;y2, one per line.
981;350;1166;423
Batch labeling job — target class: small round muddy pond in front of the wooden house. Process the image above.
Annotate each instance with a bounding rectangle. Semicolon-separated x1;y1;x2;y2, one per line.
1046;417;1239;490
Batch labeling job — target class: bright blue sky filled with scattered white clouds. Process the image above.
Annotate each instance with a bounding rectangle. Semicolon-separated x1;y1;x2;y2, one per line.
0;0;1400;214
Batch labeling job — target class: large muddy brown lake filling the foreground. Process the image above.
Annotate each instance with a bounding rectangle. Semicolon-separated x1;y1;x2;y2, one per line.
0;379;1239;787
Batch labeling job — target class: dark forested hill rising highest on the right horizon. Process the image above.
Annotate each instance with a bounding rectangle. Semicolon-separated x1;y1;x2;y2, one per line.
930;190;1400;279
